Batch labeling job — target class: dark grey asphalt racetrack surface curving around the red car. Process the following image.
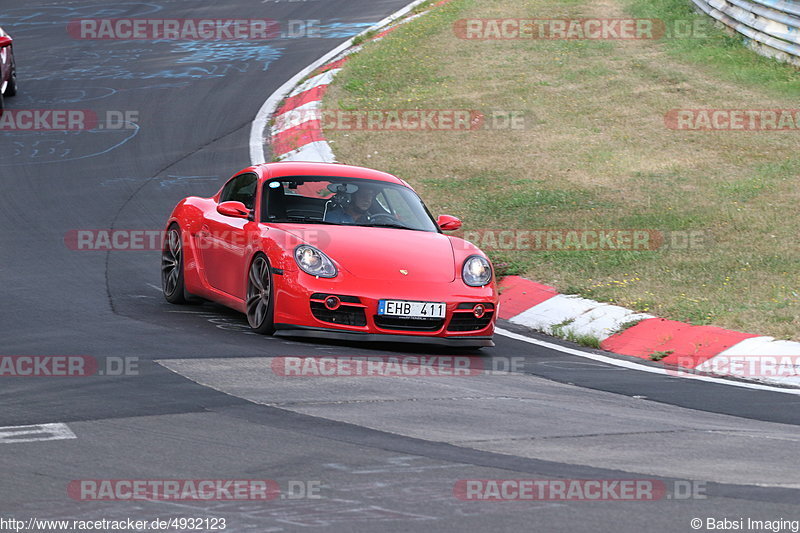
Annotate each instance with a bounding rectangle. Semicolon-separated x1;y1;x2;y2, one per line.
0;0;800;533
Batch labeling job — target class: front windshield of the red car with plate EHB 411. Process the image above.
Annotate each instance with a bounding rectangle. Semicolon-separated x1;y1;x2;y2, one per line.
261;177;439;232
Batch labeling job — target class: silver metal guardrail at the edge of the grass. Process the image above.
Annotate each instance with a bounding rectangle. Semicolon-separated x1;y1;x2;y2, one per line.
692;0;800;67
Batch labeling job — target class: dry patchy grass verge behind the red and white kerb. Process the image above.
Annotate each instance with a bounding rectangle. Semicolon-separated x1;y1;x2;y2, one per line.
325;0;800;340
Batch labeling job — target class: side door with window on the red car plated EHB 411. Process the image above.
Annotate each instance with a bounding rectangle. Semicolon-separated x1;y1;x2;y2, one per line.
198;172;258;299
